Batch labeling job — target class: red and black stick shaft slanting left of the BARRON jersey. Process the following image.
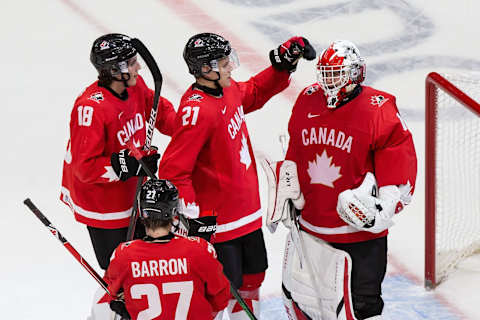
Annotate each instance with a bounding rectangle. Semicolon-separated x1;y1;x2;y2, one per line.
23;198;112;296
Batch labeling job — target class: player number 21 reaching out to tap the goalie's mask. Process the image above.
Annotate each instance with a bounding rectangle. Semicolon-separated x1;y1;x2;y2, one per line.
159;33;315;320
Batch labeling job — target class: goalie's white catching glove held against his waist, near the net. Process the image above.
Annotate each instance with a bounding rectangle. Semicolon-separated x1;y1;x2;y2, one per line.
337;172;411;233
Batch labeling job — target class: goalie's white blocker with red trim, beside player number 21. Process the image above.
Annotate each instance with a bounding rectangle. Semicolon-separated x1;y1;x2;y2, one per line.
260;157;305;233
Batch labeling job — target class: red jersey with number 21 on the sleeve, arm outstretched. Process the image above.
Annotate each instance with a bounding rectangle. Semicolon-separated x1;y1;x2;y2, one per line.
159;67;289;242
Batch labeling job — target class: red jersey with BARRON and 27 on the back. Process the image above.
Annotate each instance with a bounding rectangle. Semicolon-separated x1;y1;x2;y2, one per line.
105;236;230;320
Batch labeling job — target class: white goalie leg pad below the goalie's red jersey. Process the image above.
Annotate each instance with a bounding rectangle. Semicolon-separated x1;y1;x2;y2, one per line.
282;231;355;320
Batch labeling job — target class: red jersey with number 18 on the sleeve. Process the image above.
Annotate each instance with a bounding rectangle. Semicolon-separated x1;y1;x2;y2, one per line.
60;76;175;229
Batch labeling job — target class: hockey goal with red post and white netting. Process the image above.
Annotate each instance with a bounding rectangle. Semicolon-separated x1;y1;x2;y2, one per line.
425;72;480;289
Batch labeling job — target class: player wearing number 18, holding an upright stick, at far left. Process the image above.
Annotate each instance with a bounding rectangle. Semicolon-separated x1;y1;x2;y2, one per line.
60;33;175;270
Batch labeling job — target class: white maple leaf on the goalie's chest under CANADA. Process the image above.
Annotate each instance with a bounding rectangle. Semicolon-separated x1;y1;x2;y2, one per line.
307;150;342;188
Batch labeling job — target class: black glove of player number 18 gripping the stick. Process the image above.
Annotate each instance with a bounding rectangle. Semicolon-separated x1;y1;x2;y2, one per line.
110;149;160;181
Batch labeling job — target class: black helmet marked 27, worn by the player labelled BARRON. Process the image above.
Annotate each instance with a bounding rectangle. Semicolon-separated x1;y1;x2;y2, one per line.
137;179;179;221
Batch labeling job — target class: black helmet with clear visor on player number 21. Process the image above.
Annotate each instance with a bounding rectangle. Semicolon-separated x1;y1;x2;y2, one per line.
183;33;240;77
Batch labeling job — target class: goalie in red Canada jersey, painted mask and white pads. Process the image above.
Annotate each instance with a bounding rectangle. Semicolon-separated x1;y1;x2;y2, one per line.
265;41;417;320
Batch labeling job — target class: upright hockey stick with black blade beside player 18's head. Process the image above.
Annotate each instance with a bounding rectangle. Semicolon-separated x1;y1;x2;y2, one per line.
127;38;163;241
